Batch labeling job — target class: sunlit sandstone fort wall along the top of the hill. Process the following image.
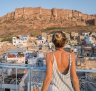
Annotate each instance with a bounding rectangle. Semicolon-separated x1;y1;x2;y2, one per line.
1;7;96;20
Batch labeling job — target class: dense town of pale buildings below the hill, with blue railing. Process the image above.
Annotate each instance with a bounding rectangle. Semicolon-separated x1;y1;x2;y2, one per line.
0;32;96;91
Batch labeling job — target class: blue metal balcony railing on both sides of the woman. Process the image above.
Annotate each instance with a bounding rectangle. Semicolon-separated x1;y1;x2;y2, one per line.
0;63;96;91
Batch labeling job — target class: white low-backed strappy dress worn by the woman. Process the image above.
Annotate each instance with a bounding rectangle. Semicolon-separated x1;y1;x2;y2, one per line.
48;54;74;91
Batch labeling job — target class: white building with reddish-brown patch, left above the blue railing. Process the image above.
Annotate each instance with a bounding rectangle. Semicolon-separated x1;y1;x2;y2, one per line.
5;48;26;64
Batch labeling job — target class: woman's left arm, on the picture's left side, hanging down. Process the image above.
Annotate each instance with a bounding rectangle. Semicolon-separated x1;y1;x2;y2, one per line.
41;53;52;91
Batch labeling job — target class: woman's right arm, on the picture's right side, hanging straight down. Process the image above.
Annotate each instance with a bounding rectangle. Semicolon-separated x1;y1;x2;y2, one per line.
71;53;80;91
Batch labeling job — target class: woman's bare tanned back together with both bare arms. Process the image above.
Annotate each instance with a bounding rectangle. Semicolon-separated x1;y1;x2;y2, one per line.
41;49;80;91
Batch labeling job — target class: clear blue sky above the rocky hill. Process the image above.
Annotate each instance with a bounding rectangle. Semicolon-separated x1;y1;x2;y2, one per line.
0;0;96;16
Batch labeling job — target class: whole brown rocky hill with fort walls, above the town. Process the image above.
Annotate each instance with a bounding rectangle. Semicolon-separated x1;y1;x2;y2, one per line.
0;7;96;35
